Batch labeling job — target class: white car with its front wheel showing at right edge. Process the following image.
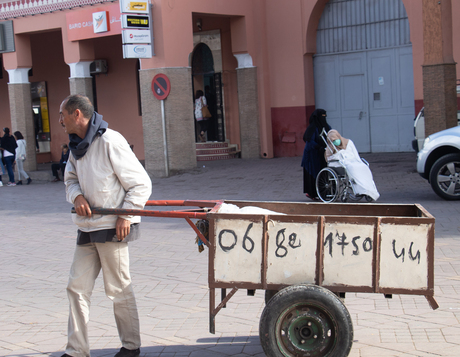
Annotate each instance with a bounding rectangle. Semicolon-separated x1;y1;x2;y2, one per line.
417;126;460;200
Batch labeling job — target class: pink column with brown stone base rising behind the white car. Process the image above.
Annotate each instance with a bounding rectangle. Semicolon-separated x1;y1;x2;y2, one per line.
423;0;457;136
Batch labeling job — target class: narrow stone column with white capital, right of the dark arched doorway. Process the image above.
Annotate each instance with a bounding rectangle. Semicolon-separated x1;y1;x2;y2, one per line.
235;53;260;159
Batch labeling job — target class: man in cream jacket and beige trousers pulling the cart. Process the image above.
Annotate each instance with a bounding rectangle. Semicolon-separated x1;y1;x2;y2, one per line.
59;95;152;357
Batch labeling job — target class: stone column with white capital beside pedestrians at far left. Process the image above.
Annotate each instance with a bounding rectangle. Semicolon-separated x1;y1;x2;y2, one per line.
7;68;37;171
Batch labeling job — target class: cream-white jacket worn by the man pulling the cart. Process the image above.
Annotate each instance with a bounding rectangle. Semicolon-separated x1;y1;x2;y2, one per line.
64;129;152;232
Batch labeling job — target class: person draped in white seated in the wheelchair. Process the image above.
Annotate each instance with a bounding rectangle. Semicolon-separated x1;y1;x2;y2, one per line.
325;129;380;201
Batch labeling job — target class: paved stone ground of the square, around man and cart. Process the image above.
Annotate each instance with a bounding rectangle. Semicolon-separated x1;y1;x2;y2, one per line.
0;153;460;357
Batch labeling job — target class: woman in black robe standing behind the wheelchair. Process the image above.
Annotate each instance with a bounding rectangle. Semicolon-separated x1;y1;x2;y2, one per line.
302;109;331;199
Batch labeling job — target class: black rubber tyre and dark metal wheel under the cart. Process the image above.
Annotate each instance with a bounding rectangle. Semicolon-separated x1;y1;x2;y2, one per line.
259;285;353;357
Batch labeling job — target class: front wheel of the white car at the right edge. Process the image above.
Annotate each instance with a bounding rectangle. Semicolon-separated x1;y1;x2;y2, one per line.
430;154;460;200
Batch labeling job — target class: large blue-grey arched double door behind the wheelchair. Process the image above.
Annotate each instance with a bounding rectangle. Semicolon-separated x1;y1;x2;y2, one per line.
313;0;415;152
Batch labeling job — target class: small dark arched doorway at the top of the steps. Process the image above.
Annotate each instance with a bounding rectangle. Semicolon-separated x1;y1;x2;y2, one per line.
192;42;225;141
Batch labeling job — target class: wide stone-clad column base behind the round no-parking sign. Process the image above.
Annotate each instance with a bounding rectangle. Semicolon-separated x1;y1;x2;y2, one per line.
139;67;197;177
